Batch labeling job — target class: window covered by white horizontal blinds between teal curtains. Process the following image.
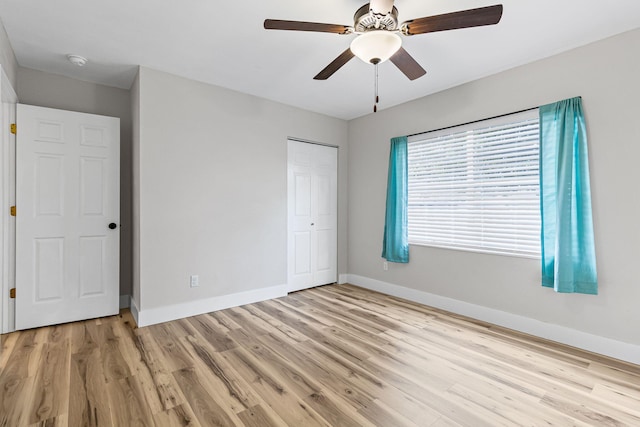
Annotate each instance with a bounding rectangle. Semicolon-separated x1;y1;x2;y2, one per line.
408;109;540;257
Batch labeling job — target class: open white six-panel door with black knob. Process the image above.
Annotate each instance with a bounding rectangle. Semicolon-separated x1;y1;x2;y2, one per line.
16;104;120;329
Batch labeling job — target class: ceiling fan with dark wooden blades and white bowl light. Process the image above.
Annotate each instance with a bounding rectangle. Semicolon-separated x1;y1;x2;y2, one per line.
264;0;502;80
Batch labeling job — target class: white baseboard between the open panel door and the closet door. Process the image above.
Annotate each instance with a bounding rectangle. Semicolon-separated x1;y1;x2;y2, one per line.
131;285;287;327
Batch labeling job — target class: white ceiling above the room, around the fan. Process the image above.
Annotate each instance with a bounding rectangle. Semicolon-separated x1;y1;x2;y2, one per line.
0;0;640;119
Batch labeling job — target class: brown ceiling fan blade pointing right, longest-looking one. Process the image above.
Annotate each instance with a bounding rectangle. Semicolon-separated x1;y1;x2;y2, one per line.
401;4;502;36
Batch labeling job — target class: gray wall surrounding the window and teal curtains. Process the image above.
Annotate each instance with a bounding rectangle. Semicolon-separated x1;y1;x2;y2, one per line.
349;30;640;344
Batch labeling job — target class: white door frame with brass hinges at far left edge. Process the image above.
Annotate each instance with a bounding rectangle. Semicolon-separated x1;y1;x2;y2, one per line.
0;66;18;334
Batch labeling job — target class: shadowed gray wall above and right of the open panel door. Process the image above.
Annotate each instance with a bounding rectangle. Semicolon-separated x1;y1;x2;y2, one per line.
16;67;133;295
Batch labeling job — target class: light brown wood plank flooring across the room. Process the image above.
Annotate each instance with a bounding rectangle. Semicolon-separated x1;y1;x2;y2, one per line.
0;285;640;427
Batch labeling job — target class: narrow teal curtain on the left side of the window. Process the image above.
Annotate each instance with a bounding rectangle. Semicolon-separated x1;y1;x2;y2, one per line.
382;136;409;263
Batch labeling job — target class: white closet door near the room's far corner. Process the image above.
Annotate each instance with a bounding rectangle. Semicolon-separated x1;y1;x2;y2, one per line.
288;140;338;292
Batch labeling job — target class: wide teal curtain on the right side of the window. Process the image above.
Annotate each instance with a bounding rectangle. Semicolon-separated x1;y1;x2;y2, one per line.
540;98;598;294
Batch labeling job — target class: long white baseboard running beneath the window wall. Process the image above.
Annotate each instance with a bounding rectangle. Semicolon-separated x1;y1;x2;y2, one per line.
347;274;640;365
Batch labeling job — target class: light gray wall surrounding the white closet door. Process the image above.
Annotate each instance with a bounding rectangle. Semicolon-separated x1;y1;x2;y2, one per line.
134;67;347;324
